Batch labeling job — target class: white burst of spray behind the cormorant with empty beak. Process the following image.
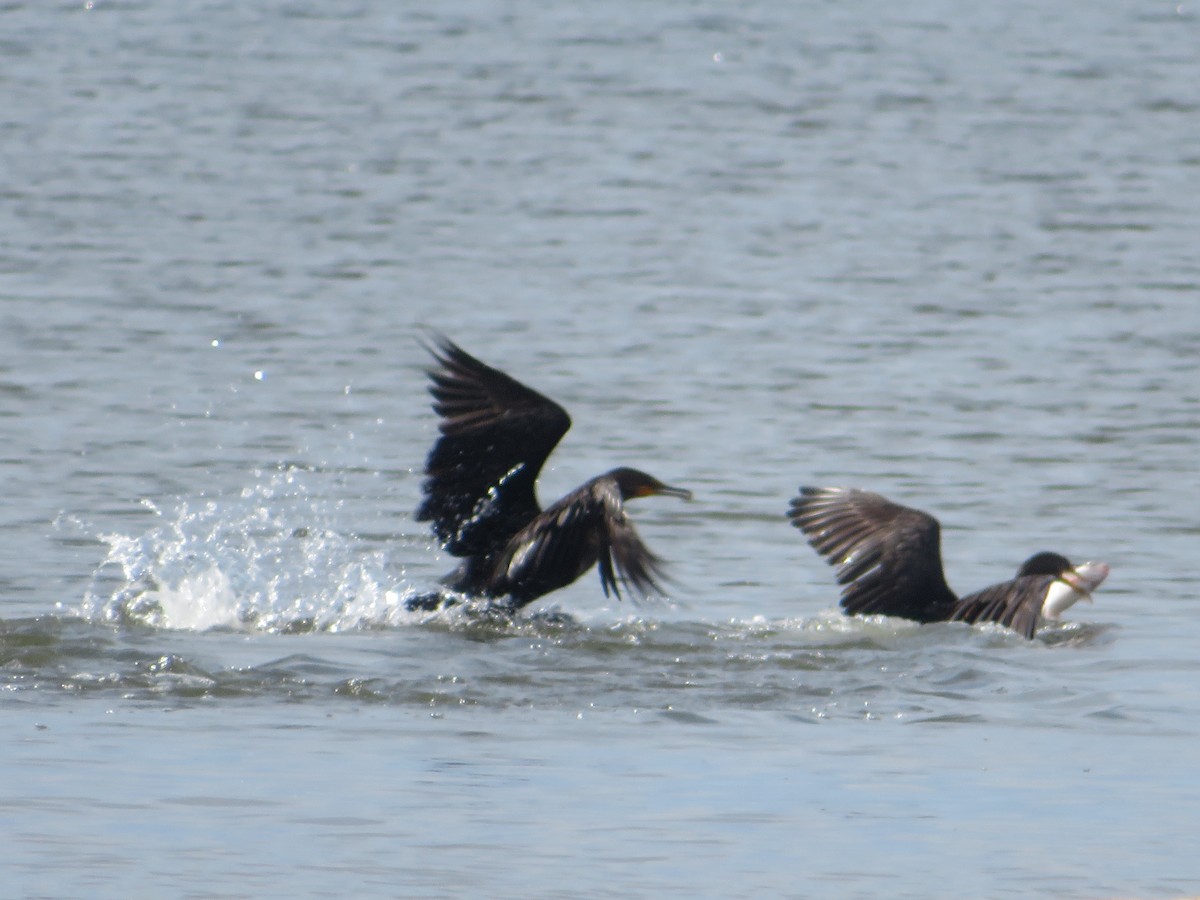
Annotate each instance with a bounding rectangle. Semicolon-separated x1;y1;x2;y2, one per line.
79;467;414;632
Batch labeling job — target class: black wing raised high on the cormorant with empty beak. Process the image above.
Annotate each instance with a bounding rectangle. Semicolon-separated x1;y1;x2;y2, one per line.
416;336;571;557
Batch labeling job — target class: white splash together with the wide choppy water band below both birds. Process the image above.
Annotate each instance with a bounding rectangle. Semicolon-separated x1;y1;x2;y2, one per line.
14;469;1110;721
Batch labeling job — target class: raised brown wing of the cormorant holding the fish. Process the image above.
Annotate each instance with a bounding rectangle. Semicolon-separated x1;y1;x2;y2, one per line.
787;487;956;622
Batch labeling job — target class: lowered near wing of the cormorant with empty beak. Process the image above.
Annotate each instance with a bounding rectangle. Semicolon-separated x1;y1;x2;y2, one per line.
490;475;662;606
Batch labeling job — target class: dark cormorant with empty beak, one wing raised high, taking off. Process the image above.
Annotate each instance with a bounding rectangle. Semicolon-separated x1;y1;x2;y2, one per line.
409;337;691;610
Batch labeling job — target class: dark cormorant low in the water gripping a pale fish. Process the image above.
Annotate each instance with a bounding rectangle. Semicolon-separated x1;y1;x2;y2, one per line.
787;487;1109;638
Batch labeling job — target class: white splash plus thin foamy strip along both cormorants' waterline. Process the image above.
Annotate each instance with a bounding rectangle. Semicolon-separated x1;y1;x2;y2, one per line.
58;468;1104;648
